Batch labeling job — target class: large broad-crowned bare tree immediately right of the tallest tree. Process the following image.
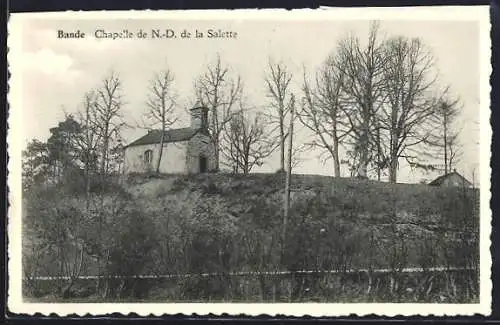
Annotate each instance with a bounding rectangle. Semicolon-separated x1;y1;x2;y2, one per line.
378;37;437;183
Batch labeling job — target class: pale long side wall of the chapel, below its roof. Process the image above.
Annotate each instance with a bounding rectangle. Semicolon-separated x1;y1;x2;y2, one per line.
125;141;188;173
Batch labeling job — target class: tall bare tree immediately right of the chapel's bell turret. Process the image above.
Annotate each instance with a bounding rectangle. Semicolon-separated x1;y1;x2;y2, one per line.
194;55;243;170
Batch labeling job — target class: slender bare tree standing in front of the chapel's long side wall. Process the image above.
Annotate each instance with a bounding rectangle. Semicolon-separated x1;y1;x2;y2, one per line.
144;69;177;174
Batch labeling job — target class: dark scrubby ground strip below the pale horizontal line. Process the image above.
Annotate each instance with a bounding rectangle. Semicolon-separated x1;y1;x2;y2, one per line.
28;270;478;303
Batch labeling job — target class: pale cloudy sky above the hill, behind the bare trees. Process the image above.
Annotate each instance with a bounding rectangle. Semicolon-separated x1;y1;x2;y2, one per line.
9;10;480;183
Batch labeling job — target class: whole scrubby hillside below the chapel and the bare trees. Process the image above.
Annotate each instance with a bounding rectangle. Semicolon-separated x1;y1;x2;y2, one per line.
25;173;479;301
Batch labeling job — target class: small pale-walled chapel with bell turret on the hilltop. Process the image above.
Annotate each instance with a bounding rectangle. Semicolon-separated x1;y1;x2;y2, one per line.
124;107;216;174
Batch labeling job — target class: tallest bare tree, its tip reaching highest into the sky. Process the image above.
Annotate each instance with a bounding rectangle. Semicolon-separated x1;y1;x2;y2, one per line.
337;22;386;177
